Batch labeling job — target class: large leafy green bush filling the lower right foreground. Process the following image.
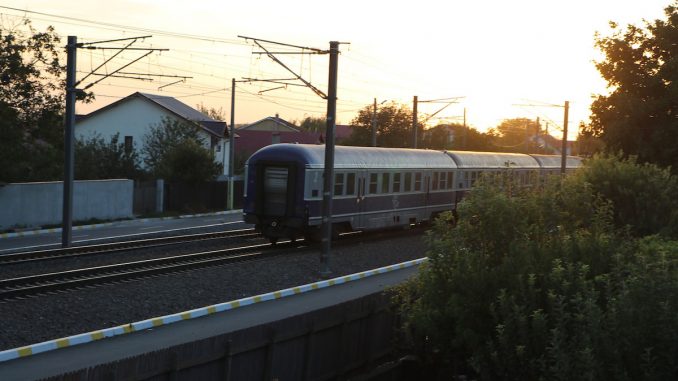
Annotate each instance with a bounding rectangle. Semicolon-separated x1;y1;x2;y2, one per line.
396;157;678;380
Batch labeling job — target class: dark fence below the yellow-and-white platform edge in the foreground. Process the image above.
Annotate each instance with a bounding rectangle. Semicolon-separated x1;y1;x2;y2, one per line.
43;294;404;381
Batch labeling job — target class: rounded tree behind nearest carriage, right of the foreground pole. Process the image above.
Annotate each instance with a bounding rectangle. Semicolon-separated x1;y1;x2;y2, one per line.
345;102;412;148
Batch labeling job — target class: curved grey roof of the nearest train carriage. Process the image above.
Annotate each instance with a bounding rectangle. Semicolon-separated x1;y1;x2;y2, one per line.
248;143;456;169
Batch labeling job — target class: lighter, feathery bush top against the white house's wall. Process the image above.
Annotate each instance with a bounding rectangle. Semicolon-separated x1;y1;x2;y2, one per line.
141;117;204;175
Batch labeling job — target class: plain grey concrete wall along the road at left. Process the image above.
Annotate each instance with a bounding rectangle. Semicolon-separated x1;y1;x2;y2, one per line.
0;179;134;230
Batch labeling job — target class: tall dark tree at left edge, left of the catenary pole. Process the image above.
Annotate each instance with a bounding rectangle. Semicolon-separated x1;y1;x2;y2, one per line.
0;20;65;182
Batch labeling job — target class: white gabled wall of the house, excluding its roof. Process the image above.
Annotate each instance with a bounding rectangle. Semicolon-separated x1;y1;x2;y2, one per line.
75;98;228;173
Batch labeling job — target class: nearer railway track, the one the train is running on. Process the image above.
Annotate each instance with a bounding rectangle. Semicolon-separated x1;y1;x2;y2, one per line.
0;243;307;301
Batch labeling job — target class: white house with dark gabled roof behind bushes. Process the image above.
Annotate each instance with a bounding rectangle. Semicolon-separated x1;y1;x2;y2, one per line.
75;92;229;175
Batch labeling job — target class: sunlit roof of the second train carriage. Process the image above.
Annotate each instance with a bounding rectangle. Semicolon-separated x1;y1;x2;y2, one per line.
447;151;541;169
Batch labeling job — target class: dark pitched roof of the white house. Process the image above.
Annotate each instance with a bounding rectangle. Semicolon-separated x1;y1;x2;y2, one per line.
78;92;228;138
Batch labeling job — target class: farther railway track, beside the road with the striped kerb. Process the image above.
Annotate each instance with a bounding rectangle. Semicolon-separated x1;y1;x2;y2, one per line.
0;229;259;265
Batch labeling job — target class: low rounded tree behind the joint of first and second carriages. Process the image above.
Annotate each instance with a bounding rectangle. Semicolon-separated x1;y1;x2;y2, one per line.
422;123;497;151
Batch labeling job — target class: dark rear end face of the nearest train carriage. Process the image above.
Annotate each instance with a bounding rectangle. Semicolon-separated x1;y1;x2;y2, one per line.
243;144;318;242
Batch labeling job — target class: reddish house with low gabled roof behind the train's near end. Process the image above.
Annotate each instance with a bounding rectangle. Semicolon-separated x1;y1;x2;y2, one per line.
235;115;351;157
